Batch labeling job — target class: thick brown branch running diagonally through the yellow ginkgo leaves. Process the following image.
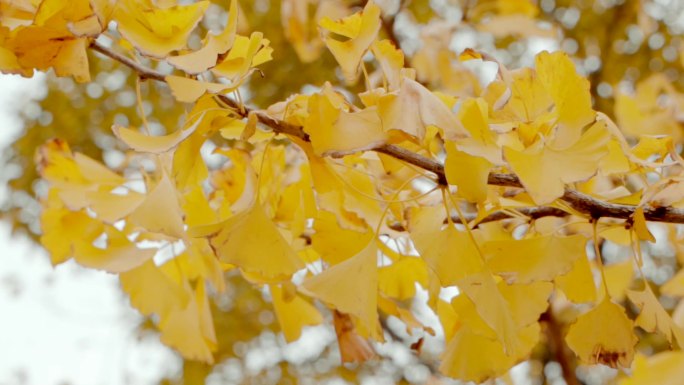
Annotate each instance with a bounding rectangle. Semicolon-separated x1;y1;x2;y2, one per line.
91;41;684;223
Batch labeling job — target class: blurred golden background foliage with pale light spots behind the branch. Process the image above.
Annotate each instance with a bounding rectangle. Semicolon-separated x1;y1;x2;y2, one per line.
0;0;684;384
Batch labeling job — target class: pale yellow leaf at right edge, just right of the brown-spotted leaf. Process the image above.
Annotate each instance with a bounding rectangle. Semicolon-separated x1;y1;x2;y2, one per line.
627;285;684;348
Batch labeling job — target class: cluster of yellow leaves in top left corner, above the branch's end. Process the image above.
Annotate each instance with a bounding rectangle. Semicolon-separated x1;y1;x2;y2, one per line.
0;0;272;102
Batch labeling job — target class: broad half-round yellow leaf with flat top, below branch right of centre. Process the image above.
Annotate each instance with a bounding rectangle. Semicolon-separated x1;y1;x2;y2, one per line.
482;234;586;283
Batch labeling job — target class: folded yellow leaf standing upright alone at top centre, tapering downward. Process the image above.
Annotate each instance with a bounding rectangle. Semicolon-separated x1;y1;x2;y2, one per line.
319;1;381;83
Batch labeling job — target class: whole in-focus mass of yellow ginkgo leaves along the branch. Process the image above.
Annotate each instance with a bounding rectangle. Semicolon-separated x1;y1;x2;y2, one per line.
14;0;684;381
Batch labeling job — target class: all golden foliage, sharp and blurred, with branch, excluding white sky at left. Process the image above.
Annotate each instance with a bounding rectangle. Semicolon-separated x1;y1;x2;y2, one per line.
5;0;684;385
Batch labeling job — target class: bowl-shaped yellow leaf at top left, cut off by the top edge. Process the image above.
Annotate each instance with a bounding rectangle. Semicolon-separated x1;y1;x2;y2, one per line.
114;0;209;59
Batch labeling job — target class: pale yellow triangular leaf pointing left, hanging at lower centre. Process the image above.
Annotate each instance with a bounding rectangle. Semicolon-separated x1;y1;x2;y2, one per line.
300;240;378;336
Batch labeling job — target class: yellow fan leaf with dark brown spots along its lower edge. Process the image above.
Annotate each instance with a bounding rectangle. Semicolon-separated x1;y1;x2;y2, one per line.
565;296;638;368
